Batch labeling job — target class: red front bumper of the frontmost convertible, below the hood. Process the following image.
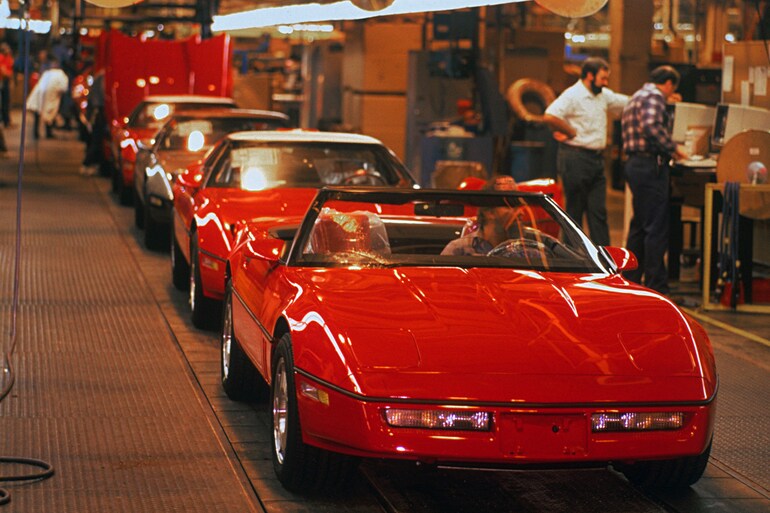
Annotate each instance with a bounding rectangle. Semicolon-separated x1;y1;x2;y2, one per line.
296;373;715;467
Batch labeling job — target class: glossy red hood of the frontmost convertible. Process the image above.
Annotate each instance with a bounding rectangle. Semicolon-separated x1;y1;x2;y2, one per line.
298;268;711;403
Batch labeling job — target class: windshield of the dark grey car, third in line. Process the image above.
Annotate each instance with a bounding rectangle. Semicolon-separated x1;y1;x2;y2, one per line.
159;116;286;152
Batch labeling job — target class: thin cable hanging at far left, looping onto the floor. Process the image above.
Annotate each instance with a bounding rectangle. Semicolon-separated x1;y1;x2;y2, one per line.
0;8;54;505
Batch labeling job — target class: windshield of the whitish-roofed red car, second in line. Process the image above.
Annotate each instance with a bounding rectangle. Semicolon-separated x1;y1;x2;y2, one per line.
207;141;414;191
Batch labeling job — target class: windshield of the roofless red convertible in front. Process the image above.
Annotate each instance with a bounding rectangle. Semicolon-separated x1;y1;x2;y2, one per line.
291;191;610;273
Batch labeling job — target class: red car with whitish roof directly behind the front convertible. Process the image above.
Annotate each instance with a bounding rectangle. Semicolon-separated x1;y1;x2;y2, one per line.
171;130;415;327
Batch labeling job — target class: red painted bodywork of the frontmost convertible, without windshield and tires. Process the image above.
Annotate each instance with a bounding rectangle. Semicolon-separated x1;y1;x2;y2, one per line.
229;190;718;465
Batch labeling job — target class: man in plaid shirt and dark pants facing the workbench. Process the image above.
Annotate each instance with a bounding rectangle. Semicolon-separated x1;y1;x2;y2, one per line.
622;66;685;295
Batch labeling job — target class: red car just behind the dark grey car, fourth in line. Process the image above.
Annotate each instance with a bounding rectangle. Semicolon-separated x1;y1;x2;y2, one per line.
110;94;236;205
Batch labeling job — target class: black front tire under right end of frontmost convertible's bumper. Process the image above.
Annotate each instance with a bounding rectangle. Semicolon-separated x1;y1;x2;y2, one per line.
619;436;712;490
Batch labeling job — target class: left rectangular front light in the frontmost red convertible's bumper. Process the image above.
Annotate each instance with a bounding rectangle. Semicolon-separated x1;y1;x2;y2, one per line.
383;408;492;431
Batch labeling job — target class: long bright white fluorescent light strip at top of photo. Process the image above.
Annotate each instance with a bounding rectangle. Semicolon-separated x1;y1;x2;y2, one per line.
211;0;524;32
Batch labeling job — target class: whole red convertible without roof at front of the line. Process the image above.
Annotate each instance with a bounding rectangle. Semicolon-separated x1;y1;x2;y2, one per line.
221;187;718;492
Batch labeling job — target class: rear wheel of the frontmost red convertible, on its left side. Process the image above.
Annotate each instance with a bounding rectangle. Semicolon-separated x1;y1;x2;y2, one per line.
219;280;268;401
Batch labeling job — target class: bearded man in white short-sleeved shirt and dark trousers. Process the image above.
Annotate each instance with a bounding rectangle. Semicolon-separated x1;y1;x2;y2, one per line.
545;57;629;246
